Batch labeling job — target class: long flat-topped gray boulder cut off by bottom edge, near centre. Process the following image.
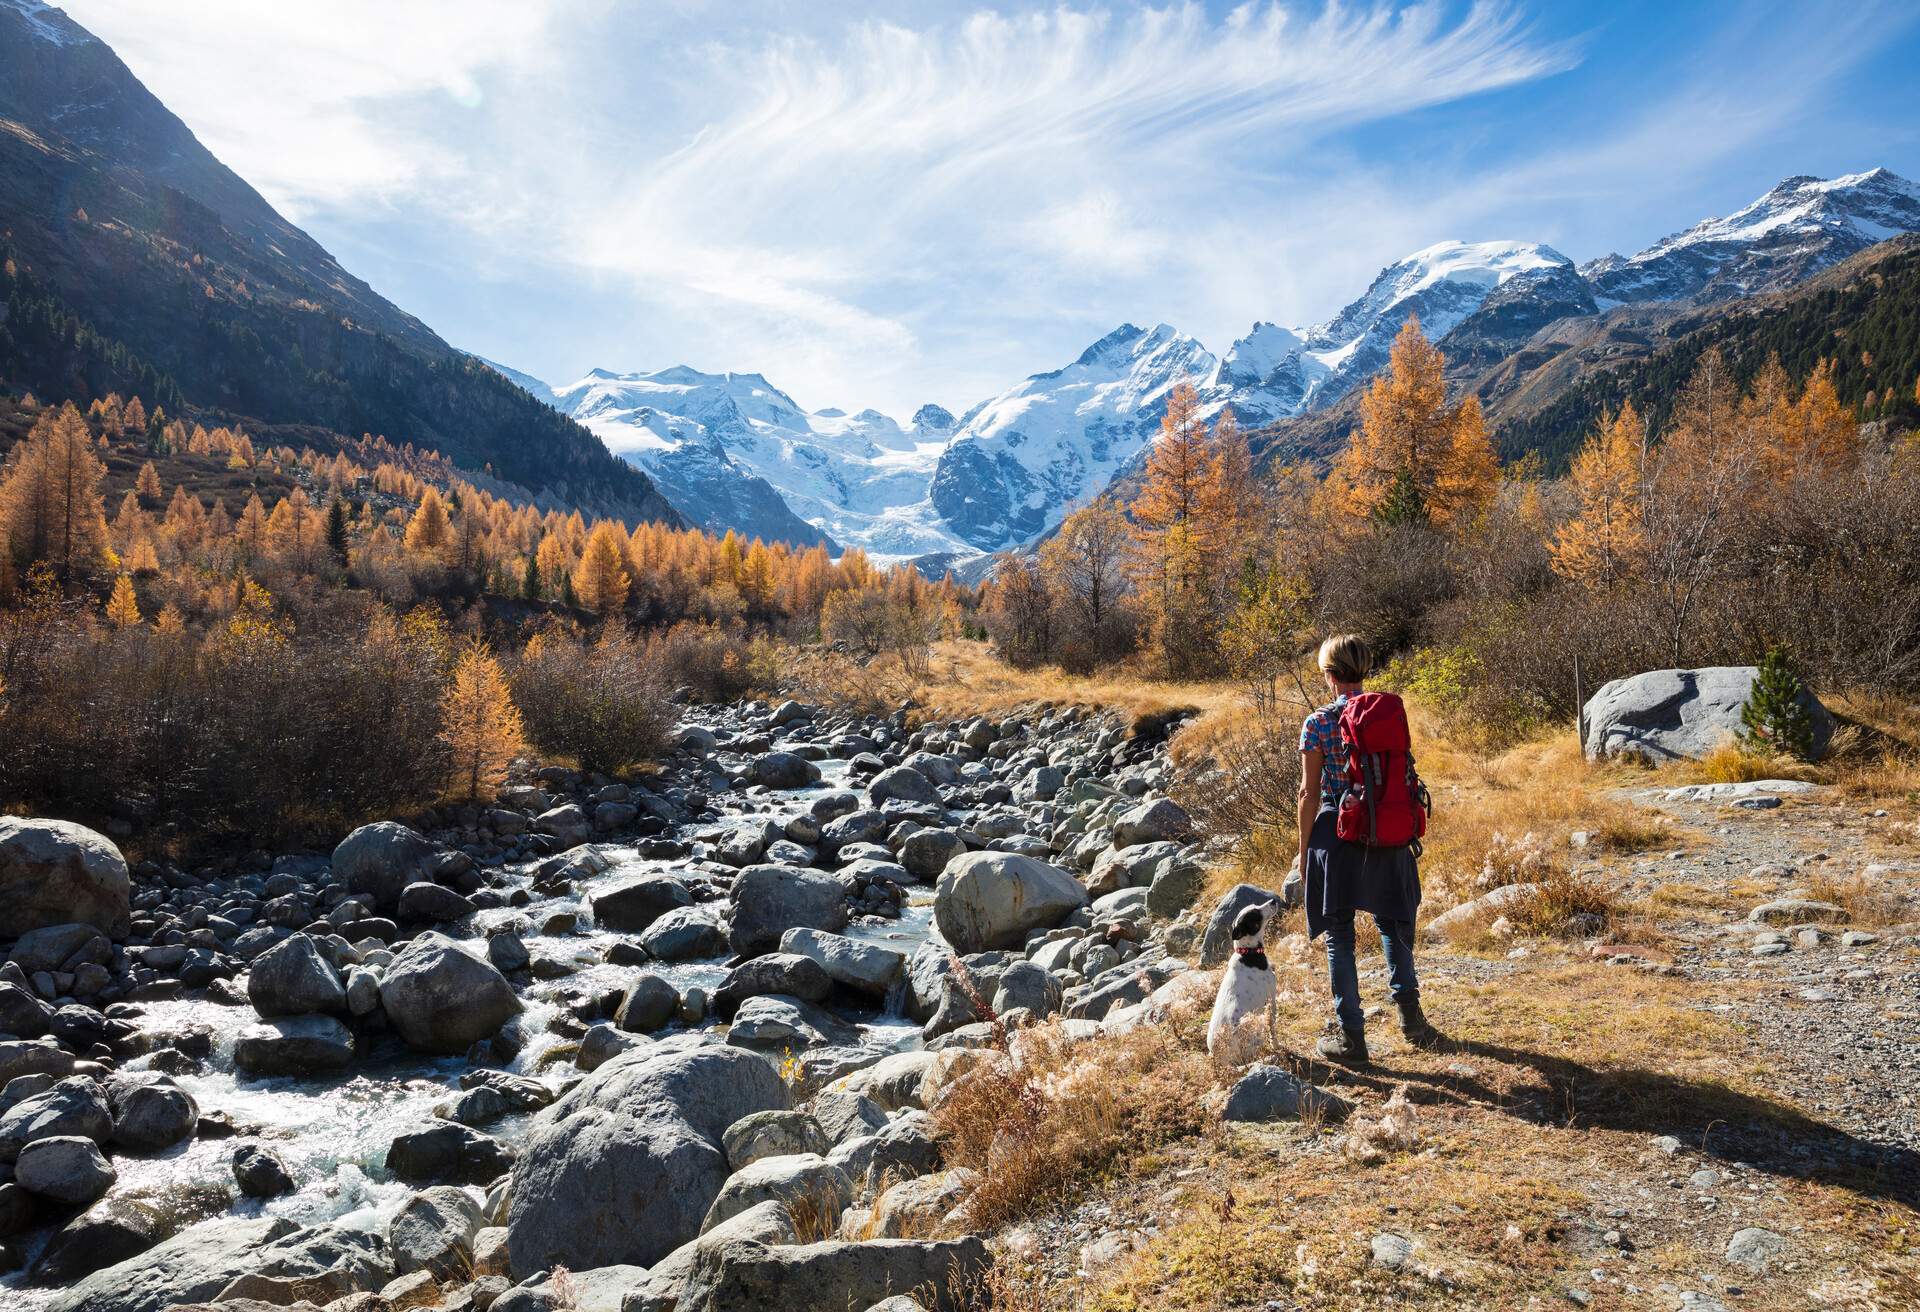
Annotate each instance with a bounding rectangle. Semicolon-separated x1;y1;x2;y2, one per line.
678;1237;993;1312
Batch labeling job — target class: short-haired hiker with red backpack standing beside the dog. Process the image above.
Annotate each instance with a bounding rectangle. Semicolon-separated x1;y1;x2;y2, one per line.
1300;634;1444;1064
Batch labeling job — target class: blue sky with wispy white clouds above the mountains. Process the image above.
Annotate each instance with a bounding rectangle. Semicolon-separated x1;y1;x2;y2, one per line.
63;0;1920;419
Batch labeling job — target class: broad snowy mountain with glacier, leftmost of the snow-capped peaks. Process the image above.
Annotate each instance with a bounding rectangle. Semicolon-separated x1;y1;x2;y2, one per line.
555;365;966;557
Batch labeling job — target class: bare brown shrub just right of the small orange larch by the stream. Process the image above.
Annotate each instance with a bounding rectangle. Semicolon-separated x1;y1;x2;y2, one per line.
511;624;674;774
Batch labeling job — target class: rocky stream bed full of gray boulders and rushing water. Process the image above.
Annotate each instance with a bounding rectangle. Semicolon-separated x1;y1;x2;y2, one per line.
0;701;1238;1312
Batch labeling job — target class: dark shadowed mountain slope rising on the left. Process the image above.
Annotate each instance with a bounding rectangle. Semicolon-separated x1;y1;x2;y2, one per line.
0;0;672;519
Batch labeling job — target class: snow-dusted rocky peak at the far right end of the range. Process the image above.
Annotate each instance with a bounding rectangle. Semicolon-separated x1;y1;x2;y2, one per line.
1580;169;1920;307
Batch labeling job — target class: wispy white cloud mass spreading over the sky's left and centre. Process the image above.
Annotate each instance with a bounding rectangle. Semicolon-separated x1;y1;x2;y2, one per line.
67;0;1574;411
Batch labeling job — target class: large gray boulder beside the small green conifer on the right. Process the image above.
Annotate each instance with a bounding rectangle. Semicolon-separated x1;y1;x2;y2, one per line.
1582;665;1834;765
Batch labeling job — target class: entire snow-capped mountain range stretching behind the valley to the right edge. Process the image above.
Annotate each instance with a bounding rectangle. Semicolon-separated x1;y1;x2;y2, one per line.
501;169;1920;563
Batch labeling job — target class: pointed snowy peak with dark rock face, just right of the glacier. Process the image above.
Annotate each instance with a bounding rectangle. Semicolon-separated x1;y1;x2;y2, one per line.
927;323;1217;551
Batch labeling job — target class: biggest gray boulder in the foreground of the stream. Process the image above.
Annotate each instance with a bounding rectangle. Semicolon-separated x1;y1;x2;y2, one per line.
507;1043;787;1275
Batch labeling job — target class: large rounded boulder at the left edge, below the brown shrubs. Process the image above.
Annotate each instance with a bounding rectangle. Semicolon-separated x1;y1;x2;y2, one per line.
0;816;132;939
